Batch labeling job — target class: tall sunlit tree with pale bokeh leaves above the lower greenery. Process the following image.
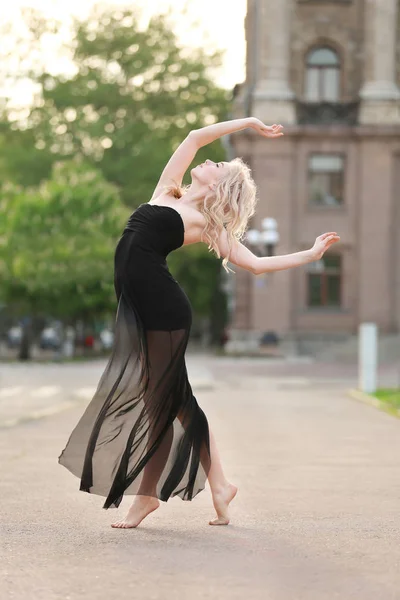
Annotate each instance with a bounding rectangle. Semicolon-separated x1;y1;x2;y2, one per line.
0;8;230;207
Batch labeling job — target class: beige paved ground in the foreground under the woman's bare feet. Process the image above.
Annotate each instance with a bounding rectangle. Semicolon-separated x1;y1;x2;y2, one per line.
0;358;400;600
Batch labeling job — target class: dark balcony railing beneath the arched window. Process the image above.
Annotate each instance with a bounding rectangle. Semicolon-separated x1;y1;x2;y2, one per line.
296;100;360;125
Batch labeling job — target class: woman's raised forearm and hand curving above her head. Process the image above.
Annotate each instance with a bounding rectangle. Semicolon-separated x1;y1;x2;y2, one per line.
190;117;283;148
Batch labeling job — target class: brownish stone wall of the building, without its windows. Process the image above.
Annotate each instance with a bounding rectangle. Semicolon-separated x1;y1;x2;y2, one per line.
228;0;400;346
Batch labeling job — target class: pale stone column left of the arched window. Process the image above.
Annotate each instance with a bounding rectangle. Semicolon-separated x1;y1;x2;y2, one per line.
253;0;296;124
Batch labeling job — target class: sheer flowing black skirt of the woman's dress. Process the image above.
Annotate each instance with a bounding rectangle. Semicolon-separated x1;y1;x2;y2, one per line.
58;246;210;509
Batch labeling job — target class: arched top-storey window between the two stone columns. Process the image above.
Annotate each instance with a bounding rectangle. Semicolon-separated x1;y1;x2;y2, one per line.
305;48;340;102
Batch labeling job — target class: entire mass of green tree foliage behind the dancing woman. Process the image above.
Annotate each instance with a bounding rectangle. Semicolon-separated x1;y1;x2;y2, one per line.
0;8;231;328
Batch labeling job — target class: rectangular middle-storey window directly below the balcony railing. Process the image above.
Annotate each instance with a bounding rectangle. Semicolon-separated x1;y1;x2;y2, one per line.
308;154;344;206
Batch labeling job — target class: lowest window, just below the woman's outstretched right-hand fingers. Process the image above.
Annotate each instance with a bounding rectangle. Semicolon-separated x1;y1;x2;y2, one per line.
307;254;342;307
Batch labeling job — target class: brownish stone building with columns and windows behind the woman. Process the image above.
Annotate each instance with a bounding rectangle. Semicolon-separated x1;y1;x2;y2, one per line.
231;0;400;354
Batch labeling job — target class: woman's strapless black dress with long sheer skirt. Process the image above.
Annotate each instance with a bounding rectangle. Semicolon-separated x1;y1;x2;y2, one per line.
58;204;211;508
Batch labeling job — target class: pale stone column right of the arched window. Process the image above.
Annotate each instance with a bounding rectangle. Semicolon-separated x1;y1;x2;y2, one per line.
360;0;400;124
